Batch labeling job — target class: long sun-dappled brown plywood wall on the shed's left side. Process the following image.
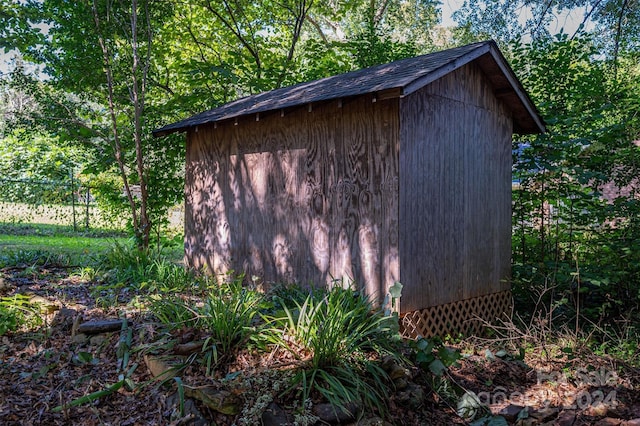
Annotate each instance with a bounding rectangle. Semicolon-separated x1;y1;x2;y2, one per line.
185;96;399;297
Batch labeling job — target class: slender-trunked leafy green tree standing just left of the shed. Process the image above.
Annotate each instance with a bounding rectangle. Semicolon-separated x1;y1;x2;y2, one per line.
7;0;181;248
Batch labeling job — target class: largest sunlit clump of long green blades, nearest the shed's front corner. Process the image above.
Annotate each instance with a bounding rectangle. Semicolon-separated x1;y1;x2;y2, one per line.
270;287;399;413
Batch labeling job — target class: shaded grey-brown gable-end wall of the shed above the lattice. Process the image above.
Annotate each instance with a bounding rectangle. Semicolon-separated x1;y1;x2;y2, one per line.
399;64;513;312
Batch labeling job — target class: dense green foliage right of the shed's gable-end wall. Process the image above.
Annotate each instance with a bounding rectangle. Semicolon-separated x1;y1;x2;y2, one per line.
512;34;640;331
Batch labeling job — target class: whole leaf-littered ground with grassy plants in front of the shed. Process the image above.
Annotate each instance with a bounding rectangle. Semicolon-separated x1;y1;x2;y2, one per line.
0;223;640;425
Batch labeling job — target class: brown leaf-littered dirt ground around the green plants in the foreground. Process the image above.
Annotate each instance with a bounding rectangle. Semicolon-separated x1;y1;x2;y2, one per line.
0;268;640;426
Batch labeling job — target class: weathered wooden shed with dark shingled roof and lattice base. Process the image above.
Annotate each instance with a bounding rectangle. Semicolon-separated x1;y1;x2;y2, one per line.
154;41;544;336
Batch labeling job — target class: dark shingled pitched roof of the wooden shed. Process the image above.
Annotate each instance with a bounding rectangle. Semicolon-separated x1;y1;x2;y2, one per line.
153;40;545;136
